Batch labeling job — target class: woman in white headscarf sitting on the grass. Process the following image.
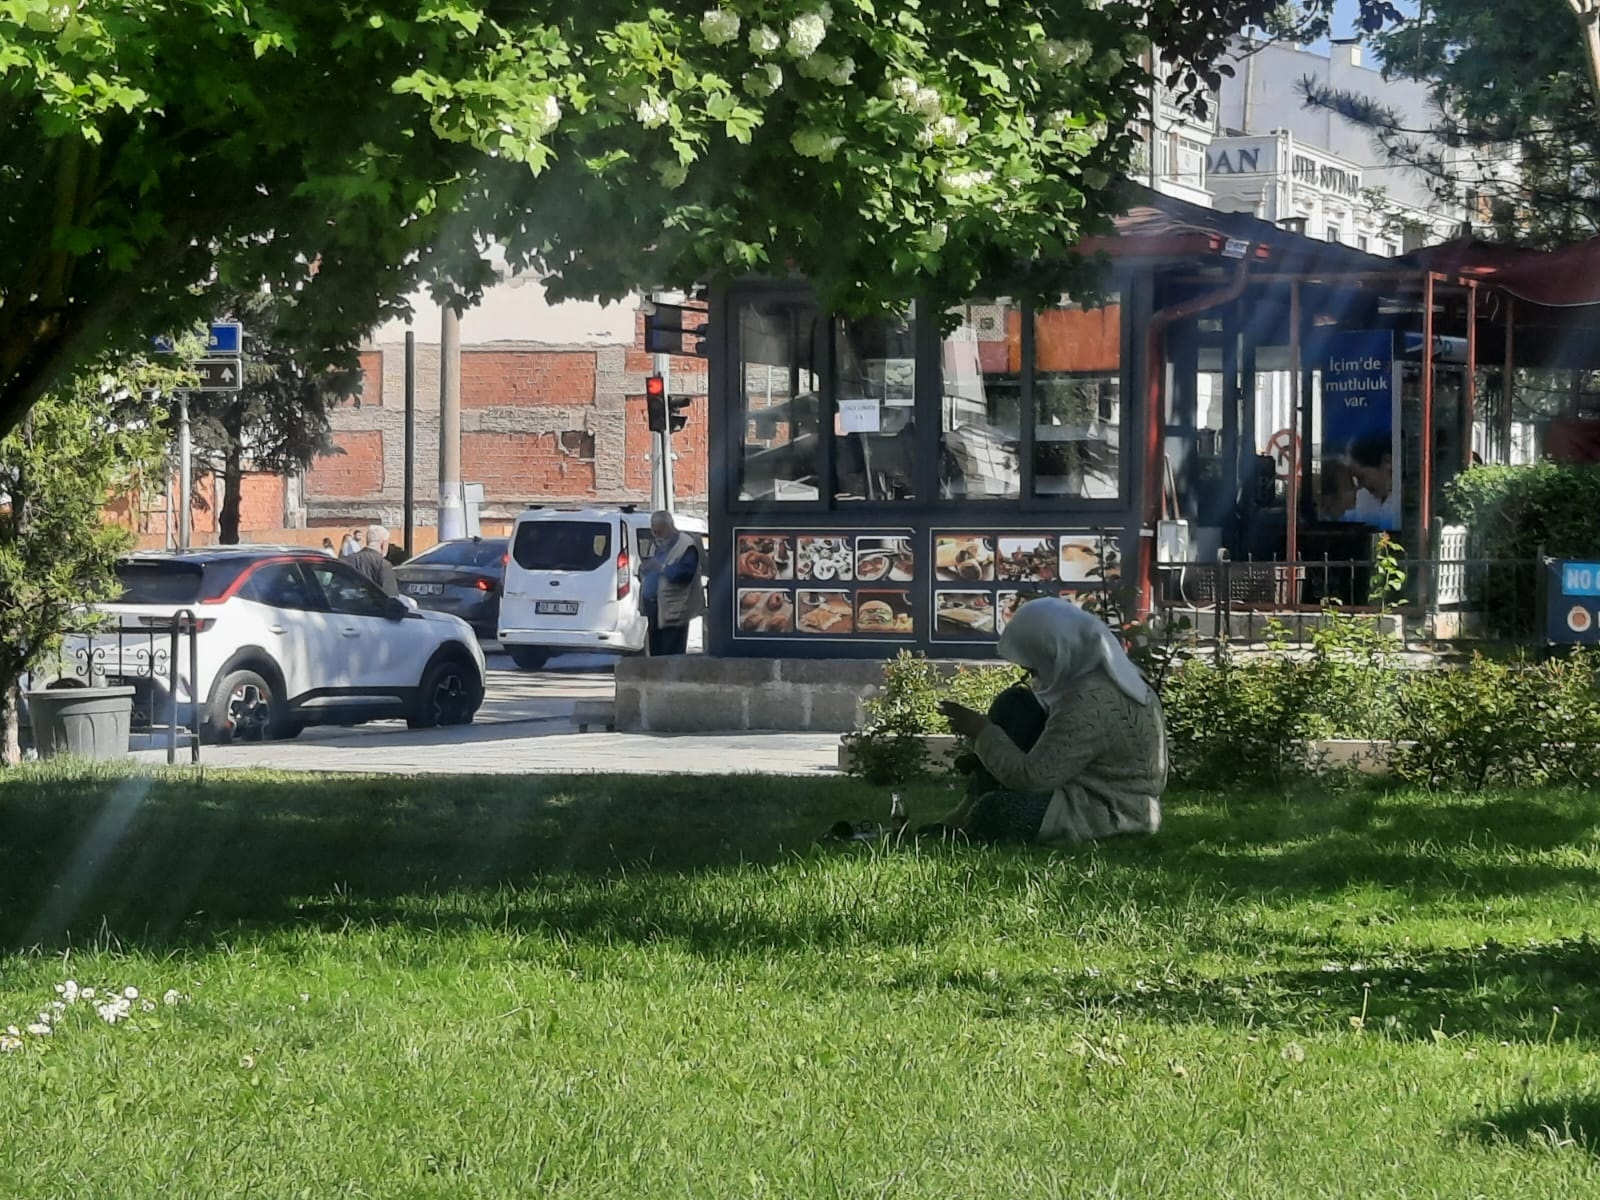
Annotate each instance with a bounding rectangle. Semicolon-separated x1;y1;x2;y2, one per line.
939;597;1166;842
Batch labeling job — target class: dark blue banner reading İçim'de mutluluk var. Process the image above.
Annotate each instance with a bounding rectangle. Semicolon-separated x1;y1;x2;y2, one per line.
1320;330;1400;531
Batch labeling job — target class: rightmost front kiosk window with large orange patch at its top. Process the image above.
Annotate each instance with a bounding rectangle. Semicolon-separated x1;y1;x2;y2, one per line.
1034;296;1122;499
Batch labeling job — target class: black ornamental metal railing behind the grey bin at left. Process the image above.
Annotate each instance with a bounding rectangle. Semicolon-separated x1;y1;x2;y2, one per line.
34;608;205;763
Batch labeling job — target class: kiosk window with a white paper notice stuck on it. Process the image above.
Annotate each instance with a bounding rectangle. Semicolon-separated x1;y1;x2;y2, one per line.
834;318;917;501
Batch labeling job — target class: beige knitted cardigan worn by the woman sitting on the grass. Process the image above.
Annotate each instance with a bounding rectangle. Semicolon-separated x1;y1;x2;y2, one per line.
974;672;1166;842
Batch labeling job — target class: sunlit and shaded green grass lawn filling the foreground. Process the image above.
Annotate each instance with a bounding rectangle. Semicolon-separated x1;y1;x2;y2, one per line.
0;768;1600;1200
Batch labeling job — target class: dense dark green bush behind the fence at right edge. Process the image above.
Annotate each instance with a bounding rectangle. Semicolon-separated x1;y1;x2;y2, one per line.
1443;462;1600;637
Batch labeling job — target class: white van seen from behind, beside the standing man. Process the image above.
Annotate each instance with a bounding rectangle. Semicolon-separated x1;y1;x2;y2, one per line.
499;507;706;670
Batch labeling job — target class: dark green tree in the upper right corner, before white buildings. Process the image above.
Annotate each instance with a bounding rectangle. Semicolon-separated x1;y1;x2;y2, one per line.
1304;0;1600;245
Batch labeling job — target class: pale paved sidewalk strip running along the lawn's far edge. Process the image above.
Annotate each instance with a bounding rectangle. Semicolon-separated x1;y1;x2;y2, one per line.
133;720;838;774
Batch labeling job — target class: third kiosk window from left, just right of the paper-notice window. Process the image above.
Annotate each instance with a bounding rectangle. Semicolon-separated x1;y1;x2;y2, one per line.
939;299;1022;499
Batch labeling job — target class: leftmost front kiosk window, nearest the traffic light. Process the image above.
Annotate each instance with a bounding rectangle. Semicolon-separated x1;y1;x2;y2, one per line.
738;299;826;501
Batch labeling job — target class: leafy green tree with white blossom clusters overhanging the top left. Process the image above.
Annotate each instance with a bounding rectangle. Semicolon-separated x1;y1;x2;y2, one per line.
0;0;1394;432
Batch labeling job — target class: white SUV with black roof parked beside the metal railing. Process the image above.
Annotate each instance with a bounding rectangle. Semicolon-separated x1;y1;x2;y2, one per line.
62;546;485;741
